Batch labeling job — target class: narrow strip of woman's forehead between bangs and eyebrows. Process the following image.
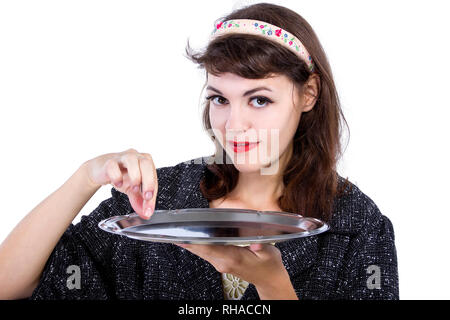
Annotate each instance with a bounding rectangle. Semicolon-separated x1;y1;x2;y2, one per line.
207;73;292;89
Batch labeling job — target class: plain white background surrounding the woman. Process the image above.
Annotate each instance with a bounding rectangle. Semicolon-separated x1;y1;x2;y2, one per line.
0;0;450;299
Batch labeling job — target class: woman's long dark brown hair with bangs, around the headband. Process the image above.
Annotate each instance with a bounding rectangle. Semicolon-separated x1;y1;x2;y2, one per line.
186;3;349;221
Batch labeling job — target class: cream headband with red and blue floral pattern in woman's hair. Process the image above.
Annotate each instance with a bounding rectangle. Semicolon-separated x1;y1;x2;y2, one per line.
210;19;314;72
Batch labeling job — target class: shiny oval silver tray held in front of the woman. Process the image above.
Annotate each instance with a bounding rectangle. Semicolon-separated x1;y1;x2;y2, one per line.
98;208;329;246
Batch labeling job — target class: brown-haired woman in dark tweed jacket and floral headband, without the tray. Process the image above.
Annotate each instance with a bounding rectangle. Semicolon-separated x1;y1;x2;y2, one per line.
0;3;399;299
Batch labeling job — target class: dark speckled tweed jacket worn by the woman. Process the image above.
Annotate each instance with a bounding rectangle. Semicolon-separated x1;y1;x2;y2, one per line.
30;158;399;300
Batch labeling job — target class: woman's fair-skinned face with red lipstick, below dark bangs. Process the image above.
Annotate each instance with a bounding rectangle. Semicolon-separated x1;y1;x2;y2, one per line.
206;73;310;174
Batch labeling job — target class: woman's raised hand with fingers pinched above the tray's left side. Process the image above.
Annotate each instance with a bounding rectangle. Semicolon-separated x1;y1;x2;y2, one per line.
85;149;158;219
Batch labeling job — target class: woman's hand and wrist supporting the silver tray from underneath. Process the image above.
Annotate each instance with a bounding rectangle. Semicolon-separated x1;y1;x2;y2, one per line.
176;243;298;299
